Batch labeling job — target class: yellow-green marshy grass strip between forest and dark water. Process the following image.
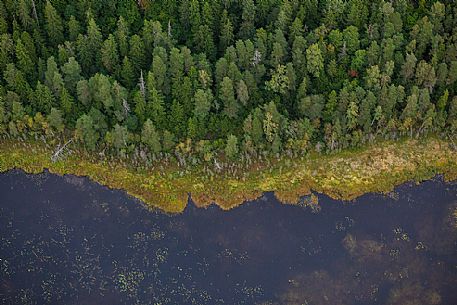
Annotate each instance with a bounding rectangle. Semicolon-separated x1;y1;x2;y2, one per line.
0;137;457;212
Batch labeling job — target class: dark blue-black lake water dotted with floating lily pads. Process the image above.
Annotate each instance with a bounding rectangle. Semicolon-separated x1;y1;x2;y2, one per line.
0;171;457;305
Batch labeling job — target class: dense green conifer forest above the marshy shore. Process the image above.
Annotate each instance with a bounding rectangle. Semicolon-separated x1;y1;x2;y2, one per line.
0;0;457;162
